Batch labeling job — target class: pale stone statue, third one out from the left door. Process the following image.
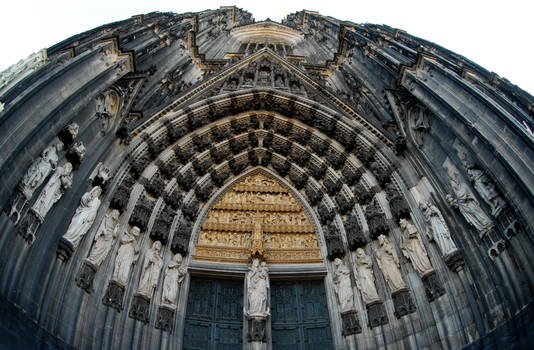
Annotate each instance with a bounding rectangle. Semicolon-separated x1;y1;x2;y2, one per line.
112;226;141;286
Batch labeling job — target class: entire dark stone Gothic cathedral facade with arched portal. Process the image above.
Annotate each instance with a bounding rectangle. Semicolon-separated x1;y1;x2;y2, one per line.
0;7;534;349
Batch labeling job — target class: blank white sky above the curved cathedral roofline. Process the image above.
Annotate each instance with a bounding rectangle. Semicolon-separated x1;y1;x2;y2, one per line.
0;0;534;95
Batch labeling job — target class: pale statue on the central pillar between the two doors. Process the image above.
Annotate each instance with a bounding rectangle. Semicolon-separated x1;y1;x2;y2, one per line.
246;259;269;316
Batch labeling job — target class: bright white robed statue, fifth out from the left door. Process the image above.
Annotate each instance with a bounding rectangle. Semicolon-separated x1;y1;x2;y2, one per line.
63;186;102;249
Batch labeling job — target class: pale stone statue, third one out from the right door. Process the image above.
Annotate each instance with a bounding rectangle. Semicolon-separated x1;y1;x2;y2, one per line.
375;235;406;293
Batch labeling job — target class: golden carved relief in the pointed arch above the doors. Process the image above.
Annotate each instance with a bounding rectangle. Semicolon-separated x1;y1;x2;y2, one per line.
194;174;322;264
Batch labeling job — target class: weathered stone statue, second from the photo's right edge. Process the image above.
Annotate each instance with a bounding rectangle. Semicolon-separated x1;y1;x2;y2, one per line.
446;179;493;235
